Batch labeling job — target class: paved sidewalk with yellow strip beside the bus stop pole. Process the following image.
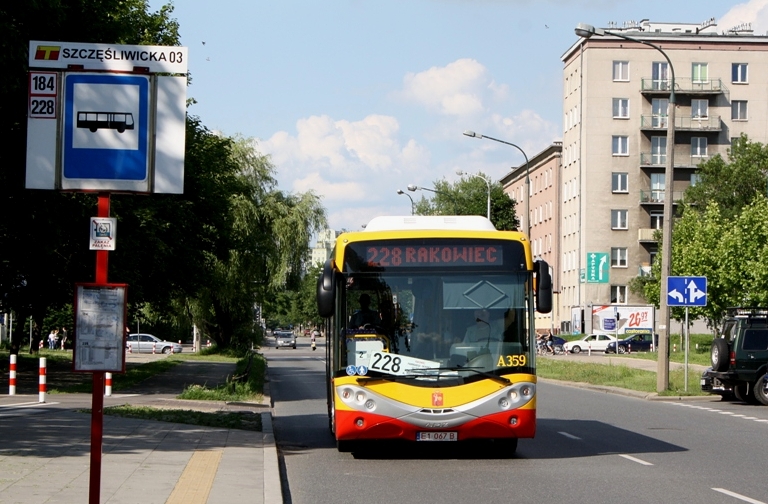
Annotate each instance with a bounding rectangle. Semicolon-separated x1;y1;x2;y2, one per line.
0;357;282;504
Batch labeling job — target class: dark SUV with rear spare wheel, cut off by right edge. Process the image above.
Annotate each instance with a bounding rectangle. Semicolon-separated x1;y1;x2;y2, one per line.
701;308;768;406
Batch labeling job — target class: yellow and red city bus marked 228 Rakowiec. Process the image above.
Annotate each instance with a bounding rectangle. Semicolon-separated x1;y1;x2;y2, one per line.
317;216;552;453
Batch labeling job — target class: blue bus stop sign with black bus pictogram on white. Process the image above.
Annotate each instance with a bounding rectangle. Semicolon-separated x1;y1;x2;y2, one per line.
62;73;149;181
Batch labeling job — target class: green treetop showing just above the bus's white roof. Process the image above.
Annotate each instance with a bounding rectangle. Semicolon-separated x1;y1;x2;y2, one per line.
414;173;520;231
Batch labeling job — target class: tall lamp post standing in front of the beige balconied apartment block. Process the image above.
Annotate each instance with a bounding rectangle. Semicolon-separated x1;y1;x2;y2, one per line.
574;23;675;392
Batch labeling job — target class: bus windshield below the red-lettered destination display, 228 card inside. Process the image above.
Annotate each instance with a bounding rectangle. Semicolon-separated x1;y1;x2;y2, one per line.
344;268;533;382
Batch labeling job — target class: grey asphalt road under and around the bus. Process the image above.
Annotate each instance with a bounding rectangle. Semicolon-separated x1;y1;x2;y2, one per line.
264;340;768;504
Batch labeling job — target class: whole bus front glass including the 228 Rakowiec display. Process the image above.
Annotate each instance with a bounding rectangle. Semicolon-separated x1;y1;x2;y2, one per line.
344;239;534;380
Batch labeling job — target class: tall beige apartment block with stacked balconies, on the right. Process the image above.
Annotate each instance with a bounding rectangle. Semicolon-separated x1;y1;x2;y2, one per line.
548;19;768;331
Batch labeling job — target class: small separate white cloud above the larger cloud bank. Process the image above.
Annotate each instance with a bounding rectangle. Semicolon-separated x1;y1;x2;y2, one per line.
395;58;488;115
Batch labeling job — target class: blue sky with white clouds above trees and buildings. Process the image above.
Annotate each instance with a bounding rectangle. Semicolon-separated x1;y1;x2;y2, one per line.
149;0;768;231
